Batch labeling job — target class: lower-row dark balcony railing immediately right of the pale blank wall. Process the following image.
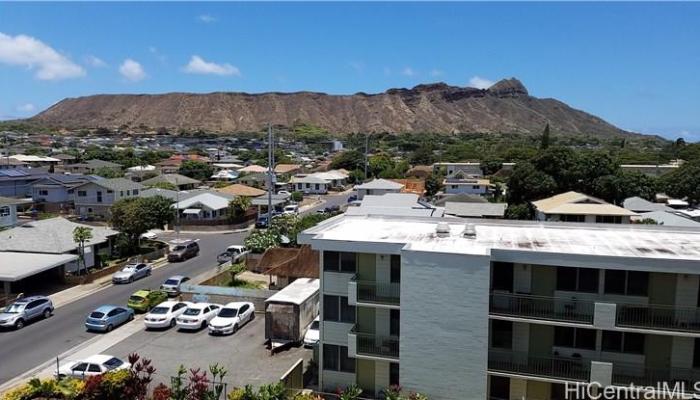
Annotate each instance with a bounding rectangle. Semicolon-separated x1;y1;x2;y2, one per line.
488;350;591;382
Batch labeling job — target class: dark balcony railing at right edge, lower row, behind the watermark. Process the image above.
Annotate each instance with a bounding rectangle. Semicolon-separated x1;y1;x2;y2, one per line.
612;362;700;393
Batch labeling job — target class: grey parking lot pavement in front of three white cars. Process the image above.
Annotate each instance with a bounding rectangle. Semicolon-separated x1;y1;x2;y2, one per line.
103;315;312;389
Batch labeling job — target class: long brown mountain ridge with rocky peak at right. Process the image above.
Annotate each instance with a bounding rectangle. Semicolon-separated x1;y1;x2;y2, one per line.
28;78;633;136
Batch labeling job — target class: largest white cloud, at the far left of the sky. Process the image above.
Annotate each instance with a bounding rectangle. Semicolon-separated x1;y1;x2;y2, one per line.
0;32;85;81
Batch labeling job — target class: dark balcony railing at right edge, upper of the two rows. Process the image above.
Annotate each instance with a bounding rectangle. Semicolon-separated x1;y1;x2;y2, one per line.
617;304;700;332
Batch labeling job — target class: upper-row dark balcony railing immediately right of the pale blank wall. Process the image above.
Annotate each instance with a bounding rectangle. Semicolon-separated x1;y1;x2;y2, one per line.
490;293;595;324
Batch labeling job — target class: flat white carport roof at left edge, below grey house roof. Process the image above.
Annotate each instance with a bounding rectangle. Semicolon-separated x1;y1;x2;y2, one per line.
0;251;78;282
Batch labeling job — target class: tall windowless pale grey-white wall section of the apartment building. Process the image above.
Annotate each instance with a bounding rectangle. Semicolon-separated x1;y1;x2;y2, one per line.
399;250;490;400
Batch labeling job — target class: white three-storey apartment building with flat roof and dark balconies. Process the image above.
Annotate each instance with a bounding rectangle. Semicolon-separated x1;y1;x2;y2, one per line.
299;215;700;400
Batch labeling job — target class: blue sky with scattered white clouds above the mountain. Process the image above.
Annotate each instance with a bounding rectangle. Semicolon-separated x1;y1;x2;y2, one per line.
0;3;700;141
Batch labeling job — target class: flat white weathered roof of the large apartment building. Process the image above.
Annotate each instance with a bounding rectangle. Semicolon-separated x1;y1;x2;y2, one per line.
299;215;700;261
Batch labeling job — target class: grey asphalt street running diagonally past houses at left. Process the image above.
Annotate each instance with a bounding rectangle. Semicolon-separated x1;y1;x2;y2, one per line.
0;232;248;384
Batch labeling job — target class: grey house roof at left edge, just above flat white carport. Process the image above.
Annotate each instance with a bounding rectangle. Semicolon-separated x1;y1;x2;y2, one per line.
0;217;119;254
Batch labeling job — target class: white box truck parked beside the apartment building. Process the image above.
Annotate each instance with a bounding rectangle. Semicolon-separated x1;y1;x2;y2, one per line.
265;278;320;354
